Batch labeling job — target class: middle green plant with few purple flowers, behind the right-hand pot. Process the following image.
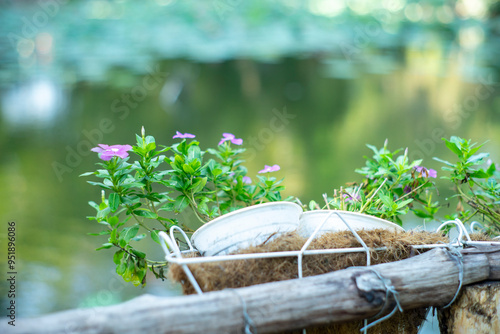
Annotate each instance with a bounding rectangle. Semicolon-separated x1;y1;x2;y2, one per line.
309;140;439;225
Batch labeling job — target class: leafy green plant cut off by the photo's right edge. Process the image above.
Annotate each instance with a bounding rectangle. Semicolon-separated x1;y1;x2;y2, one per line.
434;136;500;235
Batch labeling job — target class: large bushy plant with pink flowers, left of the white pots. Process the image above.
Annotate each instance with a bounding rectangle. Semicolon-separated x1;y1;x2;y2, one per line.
82;128;284;285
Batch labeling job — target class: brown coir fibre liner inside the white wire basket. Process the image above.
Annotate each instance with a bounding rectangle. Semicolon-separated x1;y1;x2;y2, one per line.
169;229;448;334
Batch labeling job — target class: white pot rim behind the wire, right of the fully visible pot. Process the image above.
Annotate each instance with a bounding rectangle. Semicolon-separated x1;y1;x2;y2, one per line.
298;210;404;238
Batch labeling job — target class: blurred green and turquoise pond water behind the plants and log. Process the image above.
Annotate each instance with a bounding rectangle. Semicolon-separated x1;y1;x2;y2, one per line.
0;0;500;317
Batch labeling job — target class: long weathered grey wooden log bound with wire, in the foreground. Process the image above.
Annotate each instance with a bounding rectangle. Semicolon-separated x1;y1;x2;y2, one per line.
0;247;500;334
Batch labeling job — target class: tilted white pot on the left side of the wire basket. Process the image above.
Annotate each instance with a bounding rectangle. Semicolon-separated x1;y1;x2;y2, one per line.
191;202;302;256
